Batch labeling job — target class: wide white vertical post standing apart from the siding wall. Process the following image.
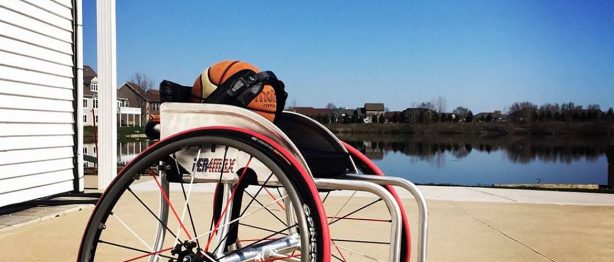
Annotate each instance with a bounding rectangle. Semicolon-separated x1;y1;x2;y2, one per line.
96;0;117;191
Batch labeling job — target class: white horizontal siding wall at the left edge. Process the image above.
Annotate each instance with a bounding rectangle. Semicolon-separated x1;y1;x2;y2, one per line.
0;0;81;209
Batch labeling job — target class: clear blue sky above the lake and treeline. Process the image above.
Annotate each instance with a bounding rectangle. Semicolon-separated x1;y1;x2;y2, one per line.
83;0;614;112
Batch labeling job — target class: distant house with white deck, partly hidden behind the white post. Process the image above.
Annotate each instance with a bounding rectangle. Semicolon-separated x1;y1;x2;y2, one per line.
83;65;144;126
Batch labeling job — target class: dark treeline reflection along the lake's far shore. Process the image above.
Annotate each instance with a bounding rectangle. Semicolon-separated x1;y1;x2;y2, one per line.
340;135;614;164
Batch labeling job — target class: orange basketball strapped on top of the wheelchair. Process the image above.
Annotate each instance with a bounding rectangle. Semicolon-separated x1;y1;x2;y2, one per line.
192;60;277;121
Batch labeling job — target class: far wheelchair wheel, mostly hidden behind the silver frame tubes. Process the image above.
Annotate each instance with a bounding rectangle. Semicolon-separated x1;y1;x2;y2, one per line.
312;143;411;262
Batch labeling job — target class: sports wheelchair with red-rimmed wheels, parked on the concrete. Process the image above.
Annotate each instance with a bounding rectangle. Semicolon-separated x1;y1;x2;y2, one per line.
78;103;428;261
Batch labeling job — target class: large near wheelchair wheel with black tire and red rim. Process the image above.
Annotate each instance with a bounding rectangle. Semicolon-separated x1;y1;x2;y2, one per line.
79;128;330;261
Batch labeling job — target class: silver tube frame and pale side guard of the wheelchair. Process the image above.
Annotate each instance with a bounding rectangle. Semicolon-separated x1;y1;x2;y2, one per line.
155;103;428;262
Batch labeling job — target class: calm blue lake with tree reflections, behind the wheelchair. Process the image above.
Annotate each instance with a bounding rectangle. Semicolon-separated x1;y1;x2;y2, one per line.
84;134;614;186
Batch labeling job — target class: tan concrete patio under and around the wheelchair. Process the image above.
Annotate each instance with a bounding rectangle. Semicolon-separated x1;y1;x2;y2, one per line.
0;184;614;261
